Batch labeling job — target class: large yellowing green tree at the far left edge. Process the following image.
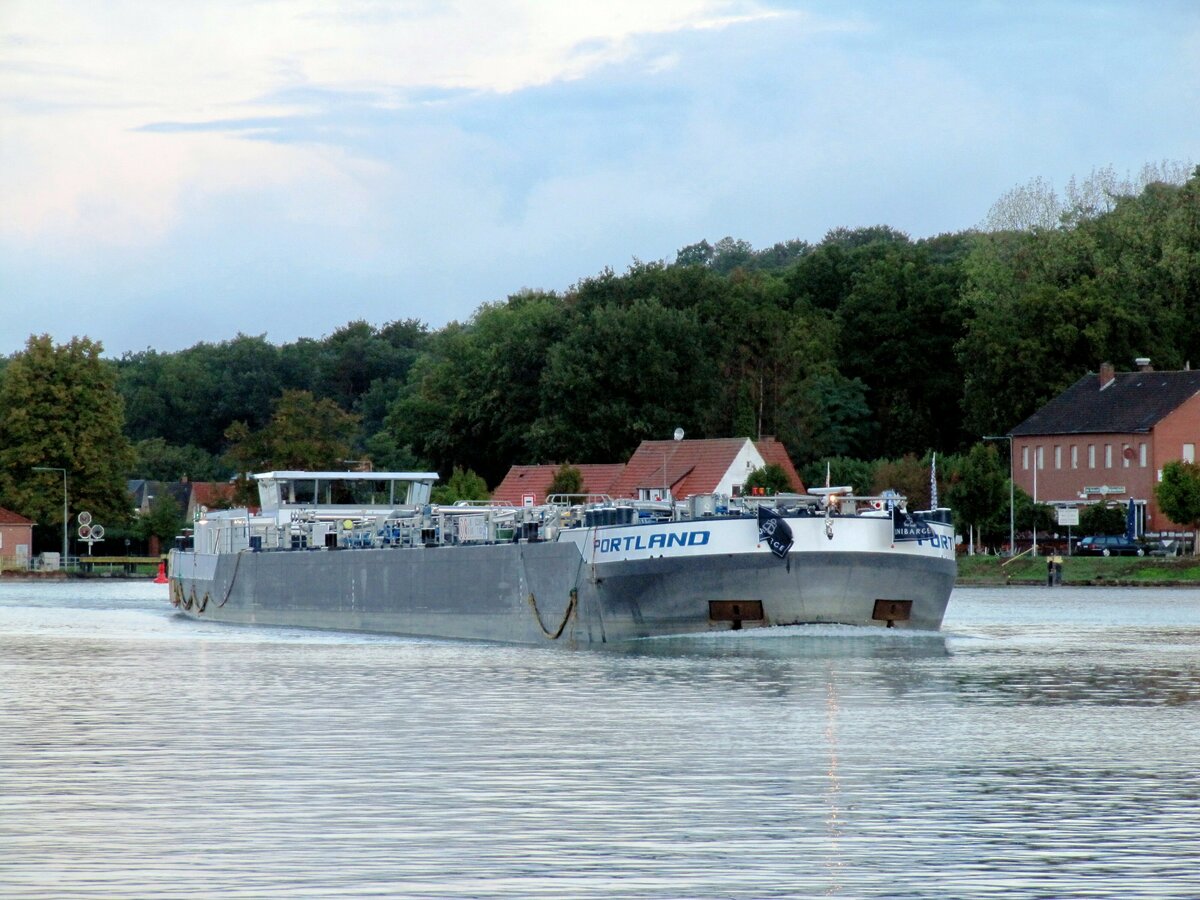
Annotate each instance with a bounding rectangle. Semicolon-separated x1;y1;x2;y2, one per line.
0;335;133;546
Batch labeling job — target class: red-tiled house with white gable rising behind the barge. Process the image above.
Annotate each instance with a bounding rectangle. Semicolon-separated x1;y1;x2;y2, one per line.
492;437;804;504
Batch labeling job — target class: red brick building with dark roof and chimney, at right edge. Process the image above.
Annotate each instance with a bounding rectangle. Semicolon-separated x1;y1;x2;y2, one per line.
1009;359;1200;534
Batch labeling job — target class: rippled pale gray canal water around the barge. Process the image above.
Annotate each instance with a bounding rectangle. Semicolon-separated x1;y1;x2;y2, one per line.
0;582;1200;899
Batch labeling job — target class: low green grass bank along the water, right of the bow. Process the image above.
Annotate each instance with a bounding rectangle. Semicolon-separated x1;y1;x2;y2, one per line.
958;556;1200;587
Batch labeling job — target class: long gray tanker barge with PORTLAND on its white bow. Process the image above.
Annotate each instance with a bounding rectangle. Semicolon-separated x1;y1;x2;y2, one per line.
169;472;955;647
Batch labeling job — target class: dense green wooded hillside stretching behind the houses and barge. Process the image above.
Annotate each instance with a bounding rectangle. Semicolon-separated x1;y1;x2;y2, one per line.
0;168;1200;554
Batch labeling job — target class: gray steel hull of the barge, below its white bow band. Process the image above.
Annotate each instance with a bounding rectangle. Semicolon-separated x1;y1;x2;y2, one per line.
172;542;955;646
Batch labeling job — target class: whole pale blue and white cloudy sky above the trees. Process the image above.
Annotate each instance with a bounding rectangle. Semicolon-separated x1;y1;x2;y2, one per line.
0;0;1200;356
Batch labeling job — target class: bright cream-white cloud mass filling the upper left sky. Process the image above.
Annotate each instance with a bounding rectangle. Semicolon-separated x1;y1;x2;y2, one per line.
0;0;775;246
